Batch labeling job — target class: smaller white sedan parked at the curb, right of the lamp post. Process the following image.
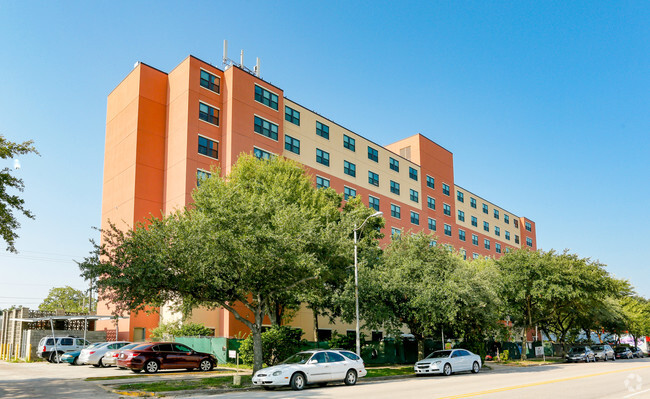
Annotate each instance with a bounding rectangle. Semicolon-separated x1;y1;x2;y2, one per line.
413;349;481;375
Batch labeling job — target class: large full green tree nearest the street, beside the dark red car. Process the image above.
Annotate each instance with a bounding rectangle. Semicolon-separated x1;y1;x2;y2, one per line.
81;155;354;370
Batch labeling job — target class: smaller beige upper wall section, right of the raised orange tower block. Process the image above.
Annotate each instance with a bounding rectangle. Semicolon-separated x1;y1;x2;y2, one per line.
452;186;522;248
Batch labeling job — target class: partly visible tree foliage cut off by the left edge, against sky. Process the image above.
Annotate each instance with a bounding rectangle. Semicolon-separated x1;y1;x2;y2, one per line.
0;134;38;252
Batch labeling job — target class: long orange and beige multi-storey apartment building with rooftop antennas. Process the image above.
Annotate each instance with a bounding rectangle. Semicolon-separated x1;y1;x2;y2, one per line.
98;56;537;340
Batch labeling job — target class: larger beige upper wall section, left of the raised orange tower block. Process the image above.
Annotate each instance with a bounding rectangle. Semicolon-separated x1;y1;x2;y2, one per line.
282;98;423;209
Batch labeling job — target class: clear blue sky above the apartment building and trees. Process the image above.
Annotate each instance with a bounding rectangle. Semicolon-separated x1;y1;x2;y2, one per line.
0;0;650;308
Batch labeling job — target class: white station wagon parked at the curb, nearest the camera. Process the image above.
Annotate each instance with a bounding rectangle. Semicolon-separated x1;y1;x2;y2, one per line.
253;349;367;391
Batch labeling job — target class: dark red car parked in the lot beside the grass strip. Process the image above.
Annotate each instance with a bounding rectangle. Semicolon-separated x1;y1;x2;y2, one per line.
117;342;217;373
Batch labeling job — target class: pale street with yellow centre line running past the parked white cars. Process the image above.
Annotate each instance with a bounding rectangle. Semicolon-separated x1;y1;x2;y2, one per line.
180;358;650;399
